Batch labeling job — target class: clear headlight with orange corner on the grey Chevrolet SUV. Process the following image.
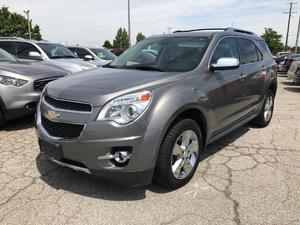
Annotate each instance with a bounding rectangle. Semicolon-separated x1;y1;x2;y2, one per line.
97;91;152;124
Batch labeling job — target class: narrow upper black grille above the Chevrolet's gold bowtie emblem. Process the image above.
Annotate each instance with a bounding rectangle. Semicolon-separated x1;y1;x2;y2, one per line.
44;95;92;112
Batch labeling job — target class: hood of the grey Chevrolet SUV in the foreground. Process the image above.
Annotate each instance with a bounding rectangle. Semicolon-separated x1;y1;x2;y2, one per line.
46;68;185;106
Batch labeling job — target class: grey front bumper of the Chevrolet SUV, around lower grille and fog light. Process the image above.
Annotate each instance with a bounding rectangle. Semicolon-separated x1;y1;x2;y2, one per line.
36;99;162;186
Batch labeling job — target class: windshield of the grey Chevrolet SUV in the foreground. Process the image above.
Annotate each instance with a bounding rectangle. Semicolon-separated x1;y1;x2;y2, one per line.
108;36;208;72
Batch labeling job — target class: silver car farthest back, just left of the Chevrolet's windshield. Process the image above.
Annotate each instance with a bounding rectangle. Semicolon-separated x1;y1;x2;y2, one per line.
68;46;117;66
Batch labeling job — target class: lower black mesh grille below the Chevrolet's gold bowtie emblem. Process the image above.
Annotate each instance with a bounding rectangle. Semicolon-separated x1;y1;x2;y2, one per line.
41;115;84;139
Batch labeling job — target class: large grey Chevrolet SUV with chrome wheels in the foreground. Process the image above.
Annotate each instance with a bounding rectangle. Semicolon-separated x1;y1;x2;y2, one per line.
36;28;277;189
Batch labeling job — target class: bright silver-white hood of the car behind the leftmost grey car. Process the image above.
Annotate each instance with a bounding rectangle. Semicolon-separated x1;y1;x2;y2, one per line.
43;58;97;73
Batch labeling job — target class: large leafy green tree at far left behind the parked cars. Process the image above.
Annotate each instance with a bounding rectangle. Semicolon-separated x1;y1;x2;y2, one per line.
0;6;42;40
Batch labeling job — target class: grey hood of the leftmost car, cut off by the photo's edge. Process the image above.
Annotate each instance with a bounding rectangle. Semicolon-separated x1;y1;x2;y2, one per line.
0;61;68;77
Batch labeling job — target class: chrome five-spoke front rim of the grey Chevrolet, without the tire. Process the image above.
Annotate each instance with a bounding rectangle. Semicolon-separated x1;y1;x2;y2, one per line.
171;130;199;179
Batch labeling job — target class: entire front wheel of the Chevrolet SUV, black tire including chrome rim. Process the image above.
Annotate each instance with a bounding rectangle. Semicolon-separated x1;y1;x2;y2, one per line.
154;119;203;189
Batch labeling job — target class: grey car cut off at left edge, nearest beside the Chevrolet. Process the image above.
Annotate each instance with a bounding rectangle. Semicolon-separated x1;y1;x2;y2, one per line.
0;48;68;127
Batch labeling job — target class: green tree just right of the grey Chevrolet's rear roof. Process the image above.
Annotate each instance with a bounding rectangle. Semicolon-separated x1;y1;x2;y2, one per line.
261;28;284;55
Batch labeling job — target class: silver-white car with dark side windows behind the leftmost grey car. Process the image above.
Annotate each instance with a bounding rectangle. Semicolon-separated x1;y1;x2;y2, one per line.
0;37;96;73
